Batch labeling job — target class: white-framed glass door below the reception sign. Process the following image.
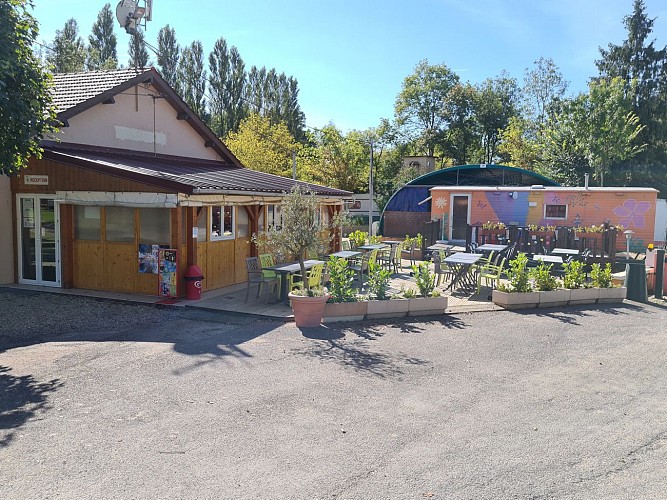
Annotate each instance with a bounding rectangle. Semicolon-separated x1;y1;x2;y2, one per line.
18;196;60;286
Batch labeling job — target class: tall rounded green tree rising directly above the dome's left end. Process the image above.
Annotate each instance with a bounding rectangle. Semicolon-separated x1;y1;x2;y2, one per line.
394;60;459;156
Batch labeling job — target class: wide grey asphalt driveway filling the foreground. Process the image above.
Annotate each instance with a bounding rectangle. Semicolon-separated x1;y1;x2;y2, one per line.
0;303;667;500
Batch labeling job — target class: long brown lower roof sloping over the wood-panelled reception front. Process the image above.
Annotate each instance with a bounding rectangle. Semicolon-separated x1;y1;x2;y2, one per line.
44;144;352;198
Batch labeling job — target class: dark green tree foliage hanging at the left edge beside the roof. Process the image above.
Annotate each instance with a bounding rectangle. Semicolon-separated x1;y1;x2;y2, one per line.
0;0;55;175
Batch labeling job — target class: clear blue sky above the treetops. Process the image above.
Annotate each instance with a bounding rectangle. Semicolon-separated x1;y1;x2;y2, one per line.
33;0;667;131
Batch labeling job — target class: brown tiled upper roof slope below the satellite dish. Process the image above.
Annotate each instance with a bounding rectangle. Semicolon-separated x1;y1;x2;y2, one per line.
52;68;146;113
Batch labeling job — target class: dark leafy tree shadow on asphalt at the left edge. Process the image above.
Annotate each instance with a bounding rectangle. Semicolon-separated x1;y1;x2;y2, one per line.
0;365;63;448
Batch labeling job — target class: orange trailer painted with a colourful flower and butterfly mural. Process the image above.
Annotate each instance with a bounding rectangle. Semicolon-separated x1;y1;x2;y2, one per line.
431;186;658;248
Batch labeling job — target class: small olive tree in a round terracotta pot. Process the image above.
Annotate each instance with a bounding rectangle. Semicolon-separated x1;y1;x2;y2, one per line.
255;185;337;327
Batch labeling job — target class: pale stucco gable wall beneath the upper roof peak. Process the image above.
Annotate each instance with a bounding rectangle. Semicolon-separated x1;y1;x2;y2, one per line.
51;85;219;160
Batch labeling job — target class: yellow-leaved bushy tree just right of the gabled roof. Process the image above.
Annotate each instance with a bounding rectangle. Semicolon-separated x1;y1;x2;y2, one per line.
225;113;299;177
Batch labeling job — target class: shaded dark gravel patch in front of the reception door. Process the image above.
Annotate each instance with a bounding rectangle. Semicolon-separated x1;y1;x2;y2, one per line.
0;289;180;341
